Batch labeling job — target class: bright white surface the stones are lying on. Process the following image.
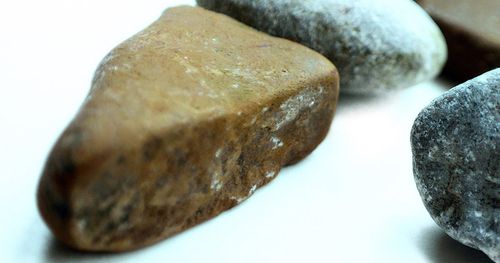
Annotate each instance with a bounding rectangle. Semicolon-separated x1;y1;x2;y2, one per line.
0;0;488;263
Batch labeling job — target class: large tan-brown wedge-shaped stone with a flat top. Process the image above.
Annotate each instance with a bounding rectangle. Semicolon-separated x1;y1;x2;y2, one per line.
37;6;338;252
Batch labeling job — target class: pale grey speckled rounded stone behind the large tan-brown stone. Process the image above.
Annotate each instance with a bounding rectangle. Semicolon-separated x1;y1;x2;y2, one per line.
197;0;447;94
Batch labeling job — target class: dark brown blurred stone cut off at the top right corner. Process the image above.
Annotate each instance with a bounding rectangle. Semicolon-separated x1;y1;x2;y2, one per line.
418;0;500;81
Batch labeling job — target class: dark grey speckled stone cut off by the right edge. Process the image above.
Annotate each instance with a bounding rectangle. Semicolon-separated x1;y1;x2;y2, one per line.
411;68;500;262
